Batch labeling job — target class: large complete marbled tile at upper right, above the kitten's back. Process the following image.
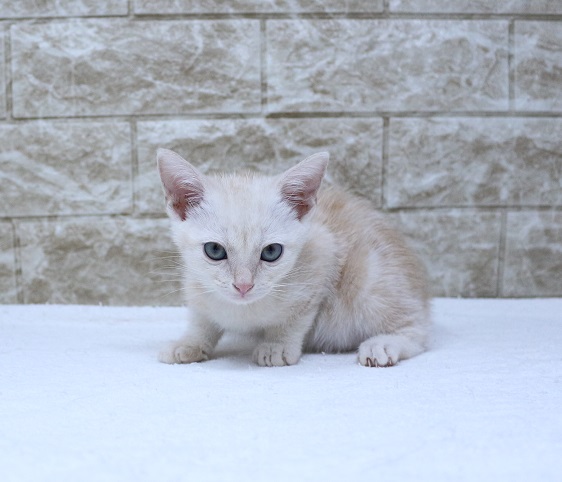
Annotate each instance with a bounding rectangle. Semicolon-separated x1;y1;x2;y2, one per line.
266;19;509;112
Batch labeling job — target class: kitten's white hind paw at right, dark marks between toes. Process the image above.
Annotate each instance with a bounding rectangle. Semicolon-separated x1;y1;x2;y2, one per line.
358;327;427;367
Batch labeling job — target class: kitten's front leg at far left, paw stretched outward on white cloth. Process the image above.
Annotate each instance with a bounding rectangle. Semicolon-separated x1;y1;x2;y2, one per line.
158;318;223;364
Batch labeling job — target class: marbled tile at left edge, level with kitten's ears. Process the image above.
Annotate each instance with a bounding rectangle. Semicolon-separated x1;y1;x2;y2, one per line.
0;121;132;216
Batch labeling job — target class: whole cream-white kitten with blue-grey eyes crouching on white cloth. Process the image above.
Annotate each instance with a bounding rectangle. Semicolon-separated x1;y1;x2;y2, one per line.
157;149;430;367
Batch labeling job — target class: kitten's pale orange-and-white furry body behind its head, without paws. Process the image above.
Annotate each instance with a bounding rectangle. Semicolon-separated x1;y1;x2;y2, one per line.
306;187;429;352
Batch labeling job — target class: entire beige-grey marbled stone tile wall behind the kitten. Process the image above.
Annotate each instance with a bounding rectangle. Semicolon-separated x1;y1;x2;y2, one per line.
0;0;562;305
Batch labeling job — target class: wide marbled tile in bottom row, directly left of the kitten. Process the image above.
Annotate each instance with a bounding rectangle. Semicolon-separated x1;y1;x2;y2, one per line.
17;217;181;305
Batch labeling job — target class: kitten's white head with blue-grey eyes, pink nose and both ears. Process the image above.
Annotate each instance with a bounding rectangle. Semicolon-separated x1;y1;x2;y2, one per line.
157;149;329;303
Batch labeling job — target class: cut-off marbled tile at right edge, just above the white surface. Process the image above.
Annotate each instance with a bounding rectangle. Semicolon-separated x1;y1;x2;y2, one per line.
501;211;562;297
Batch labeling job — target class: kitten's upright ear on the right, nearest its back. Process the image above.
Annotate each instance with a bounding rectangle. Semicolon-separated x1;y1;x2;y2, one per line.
280;152;330;220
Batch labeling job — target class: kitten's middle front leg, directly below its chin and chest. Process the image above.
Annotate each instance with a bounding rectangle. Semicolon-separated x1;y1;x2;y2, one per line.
253;311;316;367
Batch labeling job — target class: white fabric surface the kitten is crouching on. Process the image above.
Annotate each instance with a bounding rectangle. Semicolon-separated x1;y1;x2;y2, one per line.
0;299;562;482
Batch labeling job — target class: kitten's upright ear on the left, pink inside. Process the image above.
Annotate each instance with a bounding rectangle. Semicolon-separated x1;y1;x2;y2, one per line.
156;149;205;221
